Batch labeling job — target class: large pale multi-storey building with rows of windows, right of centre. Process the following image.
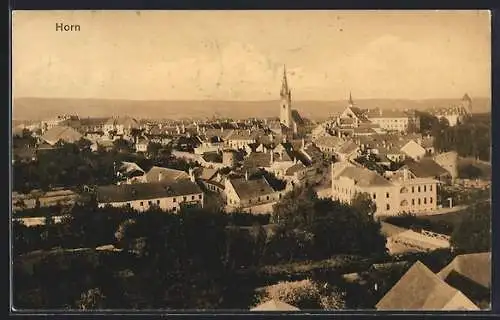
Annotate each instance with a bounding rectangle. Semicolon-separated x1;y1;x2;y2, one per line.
331;162;438;217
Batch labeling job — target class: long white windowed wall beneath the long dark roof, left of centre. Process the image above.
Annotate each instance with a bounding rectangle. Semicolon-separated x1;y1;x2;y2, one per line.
98;193;203;212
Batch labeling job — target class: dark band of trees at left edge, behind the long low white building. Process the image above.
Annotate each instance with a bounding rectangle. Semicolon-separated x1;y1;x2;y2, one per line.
13;139;192;193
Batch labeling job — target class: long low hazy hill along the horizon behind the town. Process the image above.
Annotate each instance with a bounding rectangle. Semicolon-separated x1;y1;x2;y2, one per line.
12;98;491;120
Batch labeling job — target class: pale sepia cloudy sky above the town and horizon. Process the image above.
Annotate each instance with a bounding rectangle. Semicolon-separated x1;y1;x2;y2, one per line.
12;11;491;100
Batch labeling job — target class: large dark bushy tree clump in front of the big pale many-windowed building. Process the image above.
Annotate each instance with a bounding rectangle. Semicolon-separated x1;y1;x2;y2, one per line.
272;189;386;259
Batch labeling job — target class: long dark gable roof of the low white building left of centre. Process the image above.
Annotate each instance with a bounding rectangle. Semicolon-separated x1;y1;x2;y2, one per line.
97;180;202;203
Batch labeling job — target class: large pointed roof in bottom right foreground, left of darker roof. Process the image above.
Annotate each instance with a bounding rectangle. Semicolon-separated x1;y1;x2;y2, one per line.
376;261;464;310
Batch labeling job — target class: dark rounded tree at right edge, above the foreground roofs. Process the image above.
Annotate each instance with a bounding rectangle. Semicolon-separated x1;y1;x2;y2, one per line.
451;202;491;253
